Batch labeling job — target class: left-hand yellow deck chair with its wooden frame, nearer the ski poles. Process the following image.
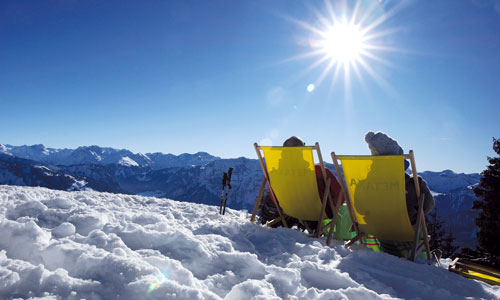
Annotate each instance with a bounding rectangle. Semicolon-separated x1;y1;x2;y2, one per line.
251;143;341;245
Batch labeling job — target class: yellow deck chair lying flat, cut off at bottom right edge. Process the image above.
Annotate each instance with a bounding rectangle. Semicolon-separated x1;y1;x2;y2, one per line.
448;257;500;285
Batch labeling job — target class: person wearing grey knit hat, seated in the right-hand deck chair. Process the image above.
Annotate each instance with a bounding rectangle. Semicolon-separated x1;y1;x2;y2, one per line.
365;131;435;257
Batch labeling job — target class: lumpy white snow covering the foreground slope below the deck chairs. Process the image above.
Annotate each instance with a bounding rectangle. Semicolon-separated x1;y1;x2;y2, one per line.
0;186;500;300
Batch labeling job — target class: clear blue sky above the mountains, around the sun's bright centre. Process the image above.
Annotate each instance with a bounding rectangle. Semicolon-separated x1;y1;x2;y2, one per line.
0;0;500;173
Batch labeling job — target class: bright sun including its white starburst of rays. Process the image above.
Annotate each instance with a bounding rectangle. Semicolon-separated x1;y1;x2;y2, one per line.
291;0;400;93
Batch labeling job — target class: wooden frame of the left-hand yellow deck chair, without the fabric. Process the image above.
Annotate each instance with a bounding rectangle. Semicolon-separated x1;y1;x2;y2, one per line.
250;143;342;245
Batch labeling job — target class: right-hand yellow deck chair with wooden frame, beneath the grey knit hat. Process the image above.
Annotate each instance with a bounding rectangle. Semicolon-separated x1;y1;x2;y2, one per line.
332;151;431;261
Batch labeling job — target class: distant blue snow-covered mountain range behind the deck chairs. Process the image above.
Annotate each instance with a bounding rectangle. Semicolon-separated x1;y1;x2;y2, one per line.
0;144;480;248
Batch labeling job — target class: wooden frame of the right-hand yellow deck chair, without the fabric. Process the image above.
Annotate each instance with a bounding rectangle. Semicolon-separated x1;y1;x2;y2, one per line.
331;150;431;261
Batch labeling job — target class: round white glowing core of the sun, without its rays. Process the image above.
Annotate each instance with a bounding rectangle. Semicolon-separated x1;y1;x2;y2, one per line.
319;22;366;63
